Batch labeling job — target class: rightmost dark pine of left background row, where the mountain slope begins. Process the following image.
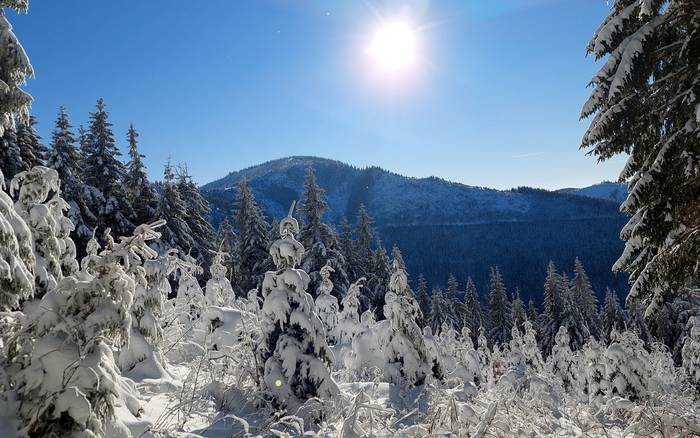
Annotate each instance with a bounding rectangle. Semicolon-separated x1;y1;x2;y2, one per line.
177;166;216;268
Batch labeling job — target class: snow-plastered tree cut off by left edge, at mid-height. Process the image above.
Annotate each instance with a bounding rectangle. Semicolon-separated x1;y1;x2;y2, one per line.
0;172;36;311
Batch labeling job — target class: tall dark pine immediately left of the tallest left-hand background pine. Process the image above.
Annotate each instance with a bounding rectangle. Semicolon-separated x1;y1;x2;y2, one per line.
46;106;102;246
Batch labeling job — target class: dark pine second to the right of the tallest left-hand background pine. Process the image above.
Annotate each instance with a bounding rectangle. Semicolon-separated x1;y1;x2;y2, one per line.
156;162;194;253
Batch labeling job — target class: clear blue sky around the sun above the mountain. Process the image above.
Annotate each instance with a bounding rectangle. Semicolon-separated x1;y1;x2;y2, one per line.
9;0;622;188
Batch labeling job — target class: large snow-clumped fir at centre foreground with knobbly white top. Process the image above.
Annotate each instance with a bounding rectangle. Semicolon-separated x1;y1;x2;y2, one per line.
257;204;339;406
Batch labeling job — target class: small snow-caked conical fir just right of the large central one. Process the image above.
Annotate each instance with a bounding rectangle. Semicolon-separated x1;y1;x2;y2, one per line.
380;260;442;385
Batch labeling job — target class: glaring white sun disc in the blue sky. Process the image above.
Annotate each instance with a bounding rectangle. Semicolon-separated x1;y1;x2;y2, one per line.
367;21;417;74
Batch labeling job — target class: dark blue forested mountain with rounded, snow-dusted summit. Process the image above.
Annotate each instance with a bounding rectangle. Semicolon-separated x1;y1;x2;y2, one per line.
202;157;627;301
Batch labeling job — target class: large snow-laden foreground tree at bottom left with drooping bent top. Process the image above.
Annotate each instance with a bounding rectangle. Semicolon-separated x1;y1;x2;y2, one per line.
15;225;163;436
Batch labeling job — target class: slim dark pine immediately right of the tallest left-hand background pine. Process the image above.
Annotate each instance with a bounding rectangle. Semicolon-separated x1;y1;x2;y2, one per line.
124;124;158;224
